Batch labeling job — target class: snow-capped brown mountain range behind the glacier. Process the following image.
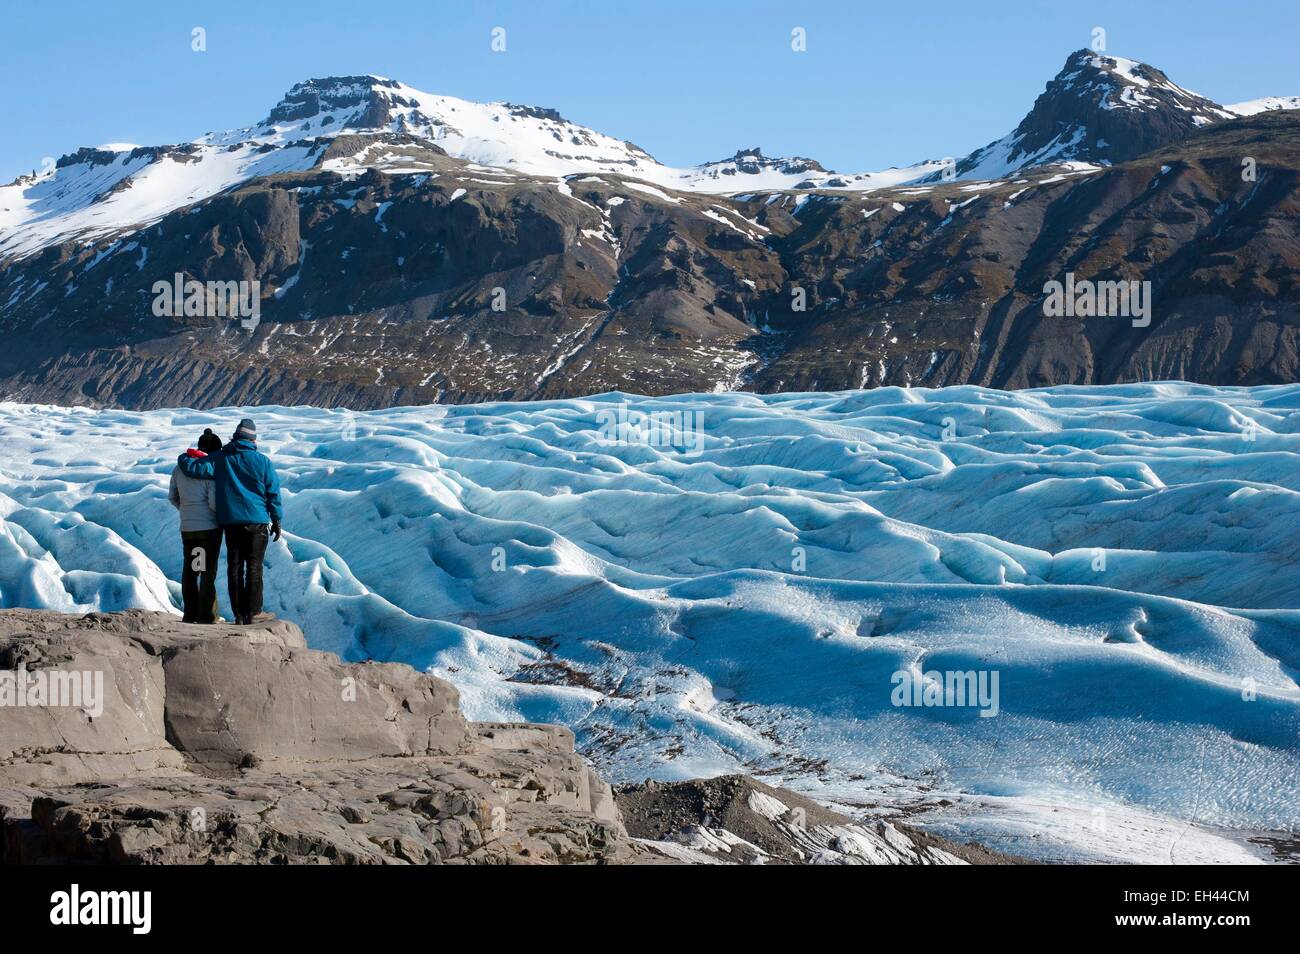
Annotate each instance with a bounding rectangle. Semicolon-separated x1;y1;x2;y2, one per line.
0;51;1300;408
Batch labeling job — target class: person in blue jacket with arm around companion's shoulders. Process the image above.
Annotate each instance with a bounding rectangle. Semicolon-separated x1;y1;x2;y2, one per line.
177;417;283;625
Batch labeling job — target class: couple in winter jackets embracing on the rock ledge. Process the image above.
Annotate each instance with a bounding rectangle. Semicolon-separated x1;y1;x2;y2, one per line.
168;417;282;624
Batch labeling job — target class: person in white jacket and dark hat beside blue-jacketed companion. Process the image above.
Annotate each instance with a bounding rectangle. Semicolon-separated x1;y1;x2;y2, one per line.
168;428;221;623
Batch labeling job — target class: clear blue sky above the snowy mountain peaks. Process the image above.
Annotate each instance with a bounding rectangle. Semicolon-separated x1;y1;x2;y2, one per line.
0;0;1300;182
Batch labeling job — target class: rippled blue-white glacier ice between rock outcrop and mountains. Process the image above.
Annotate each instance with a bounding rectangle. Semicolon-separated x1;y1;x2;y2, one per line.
0;383;1300;862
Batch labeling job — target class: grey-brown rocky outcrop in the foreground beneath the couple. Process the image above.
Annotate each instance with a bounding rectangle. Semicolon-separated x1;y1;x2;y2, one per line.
0;610;1000;864
